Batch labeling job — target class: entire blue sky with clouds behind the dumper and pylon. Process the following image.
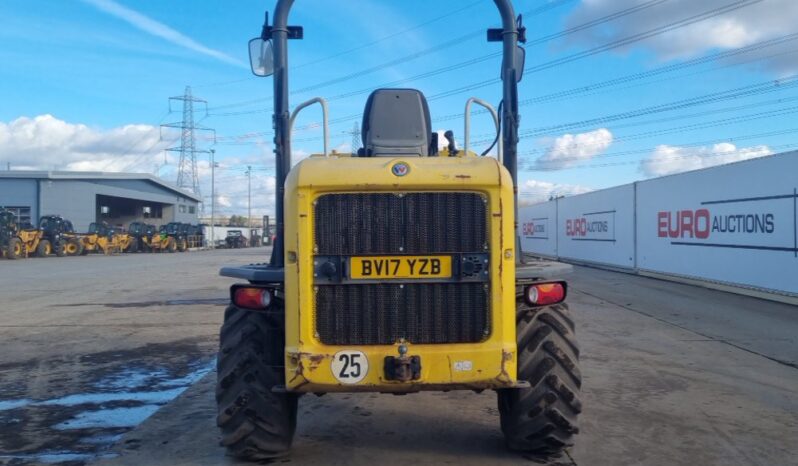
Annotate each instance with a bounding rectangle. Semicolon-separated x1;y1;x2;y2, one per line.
0;0;798;215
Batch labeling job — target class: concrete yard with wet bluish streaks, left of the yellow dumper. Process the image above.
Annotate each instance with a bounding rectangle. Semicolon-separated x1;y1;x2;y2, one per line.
0;248;268;465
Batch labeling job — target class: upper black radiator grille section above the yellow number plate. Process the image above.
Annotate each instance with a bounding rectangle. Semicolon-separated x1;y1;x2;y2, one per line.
314;192;487;256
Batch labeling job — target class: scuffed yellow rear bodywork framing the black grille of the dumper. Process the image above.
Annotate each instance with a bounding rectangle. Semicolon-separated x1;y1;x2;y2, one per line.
284;154;517;392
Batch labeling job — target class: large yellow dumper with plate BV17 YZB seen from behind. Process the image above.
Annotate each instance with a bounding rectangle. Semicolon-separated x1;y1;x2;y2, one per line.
216;0;581;460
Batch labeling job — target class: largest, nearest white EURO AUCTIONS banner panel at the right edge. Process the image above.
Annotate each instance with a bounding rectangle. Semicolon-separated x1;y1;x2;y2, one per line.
637;152;798;293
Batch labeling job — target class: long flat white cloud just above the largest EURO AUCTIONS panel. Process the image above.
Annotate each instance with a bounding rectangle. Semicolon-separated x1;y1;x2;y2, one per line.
640;142;773;176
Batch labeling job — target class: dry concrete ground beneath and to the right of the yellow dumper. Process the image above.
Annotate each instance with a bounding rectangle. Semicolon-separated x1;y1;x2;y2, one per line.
102;267;798;466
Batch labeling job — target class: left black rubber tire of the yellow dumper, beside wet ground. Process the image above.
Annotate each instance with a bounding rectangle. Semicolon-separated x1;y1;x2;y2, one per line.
216;305;297;461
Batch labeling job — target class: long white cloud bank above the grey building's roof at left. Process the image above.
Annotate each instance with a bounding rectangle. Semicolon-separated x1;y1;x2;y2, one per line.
0;115;169;172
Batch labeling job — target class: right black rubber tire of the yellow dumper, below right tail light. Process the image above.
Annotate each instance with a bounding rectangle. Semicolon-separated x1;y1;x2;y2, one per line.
498;304;582;455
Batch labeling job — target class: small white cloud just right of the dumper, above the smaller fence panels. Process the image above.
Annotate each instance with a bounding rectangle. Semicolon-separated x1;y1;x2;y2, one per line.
535;128;613;170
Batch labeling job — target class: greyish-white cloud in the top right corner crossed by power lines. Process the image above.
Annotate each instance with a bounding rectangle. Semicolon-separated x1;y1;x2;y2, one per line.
566;0;798;73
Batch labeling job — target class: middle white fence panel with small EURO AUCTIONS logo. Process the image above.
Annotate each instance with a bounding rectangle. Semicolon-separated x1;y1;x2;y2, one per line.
557;184;635;268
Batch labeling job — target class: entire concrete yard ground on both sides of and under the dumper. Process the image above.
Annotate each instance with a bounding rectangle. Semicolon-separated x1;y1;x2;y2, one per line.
0;249;798;466
